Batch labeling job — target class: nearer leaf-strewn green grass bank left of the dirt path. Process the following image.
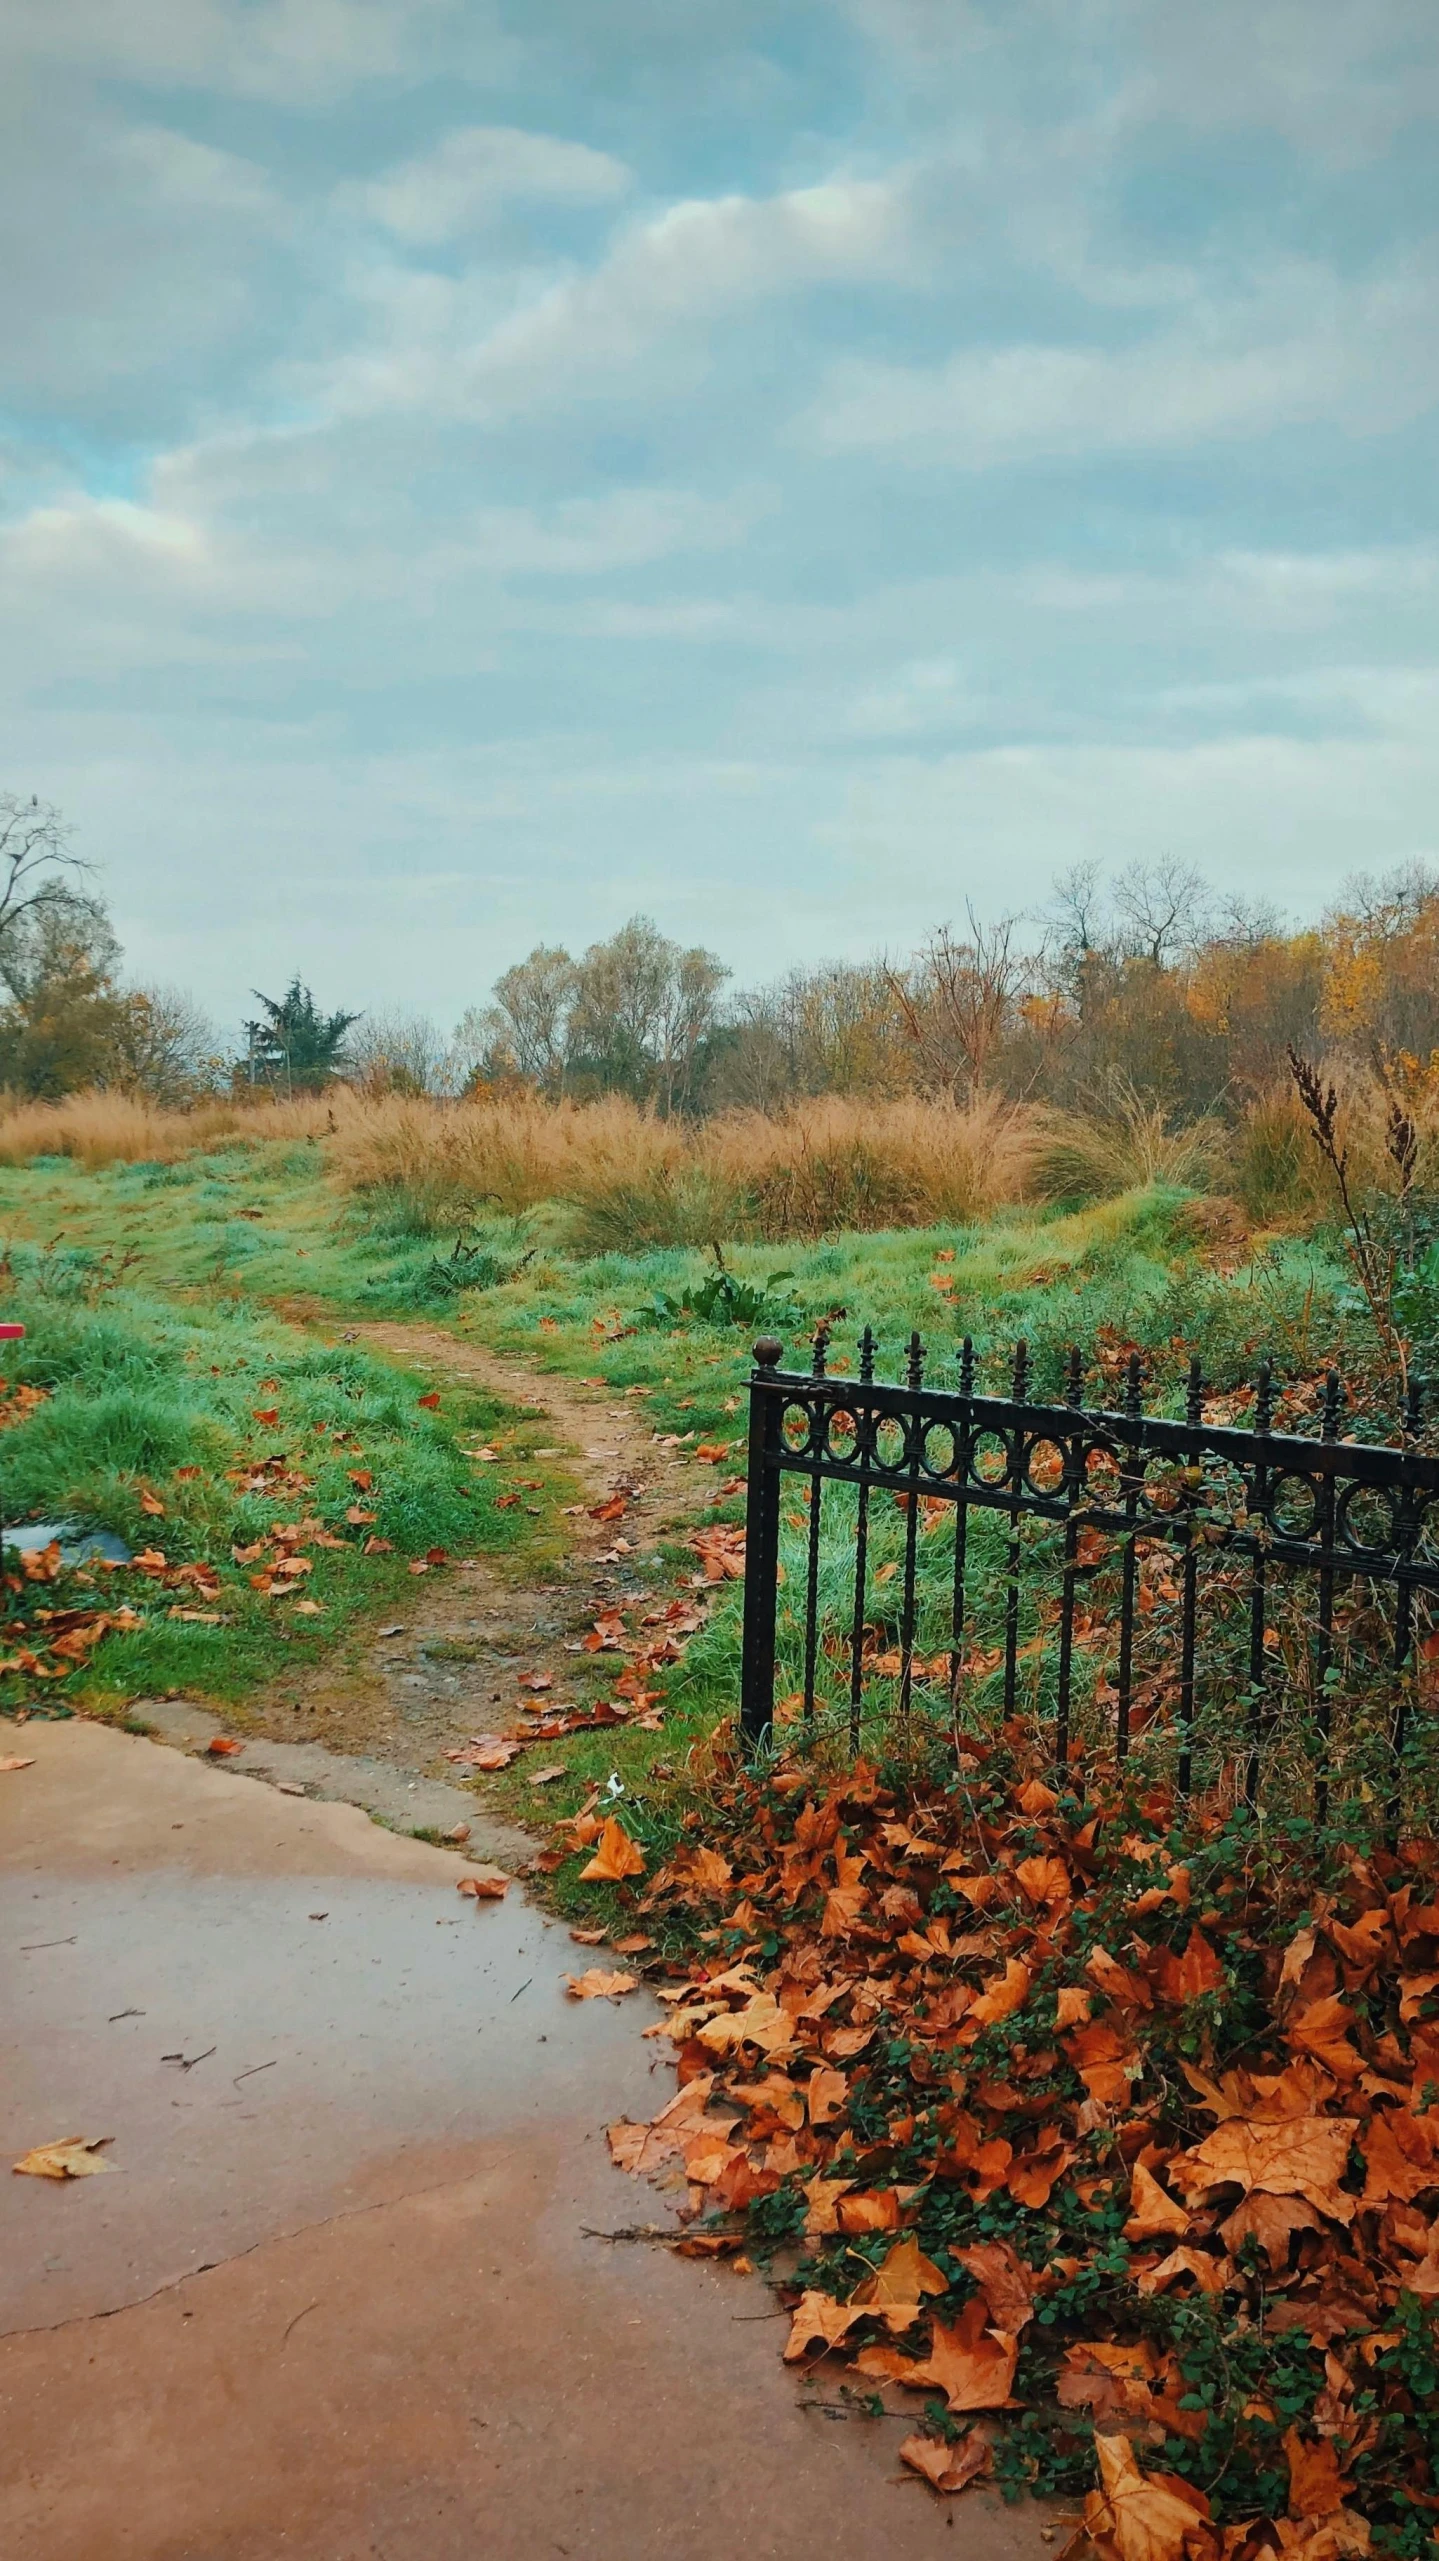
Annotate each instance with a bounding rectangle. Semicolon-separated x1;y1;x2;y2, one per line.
0;1245;574;1706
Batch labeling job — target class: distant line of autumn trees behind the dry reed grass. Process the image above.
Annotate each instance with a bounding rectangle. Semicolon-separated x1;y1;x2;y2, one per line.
0;794;1439;1122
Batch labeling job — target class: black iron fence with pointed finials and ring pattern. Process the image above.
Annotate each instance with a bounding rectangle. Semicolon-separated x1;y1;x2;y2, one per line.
743;1329;1439;1818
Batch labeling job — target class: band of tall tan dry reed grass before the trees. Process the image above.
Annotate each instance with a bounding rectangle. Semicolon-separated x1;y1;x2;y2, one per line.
0;1063;1439;1252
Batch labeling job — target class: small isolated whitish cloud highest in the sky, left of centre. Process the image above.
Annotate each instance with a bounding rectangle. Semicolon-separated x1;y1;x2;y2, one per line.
341;125;630;248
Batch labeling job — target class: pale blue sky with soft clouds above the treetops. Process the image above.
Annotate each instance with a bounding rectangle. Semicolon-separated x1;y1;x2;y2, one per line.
0;0;1439;1017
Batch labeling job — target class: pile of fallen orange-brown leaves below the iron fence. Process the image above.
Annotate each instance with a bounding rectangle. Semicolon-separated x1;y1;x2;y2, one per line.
591;1729;1439;2561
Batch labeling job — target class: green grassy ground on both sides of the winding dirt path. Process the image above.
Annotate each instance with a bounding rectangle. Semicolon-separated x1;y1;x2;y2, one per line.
0;1145;1339;1843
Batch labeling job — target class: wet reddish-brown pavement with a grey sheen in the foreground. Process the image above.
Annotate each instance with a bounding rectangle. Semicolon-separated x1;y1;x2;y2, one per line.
0;1724;1045;2561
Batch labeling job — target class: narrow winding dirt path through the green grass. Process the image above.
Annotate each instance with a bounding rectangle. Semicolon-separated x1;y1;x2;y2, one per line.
217;1324;714;1821
